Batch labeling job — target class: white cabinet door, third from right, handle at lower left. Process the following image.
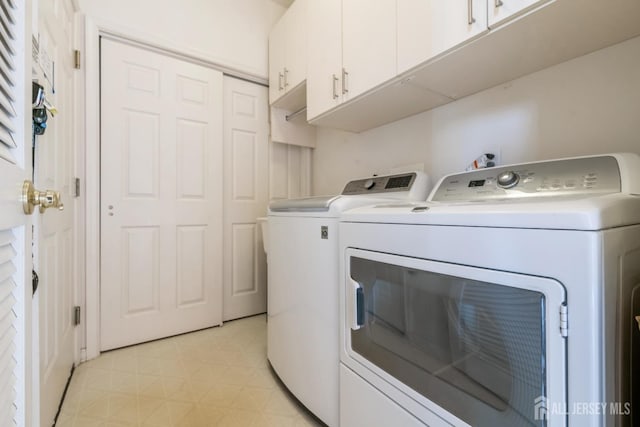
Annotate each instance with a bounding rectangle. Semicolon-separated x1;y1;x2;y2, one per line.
342;0;398;100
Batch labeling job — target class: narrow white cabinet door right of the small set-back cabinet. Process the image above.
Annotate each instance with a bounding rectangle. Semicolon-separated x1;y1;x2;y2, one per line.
307;0;342;120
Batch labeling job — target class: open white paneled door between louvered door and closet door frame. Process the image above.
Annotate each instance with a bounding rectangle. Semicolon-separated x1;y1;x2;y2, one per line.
34;0;76;426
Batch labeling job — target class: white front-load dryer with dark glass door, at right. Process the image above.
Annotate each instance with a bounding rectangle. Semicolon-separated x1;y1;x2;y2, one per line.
340;154;640;427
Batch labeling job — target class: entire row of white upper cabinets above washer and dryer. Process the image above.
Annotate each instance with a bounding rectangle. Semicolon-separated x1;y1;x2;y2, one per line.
270;0;640;132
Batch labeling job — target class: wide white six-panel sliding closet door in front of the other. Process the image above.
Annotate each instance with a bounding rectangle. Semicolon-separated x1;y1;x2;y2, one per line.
100;38;223;350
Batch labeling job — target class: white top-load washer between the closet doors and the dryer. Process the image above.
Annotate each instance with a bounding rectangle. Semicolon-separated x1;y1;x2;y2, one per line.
267;172;429;426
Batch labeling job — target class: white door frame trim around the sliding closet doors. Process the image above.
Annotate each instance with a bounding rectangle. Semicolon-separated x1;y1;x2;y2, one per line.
78;15;268;361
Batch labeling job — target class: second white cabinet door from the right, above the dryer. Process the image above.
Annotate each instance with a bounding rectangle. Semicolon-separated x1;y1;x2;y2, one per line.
398;0;488;73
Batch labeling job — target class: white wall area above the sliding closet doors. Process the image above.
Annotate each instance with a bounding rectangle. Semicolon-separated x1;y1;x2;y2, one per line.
78;0;286;79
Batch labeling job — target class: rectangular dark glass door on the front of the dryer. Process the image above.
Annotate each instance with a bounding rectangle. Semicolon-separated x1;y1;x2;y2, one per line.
346;250;565;427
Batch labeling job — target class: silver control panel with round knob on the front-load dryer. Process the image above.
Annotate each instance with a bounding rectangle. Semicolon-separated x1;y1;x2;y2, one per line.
430;156;622;201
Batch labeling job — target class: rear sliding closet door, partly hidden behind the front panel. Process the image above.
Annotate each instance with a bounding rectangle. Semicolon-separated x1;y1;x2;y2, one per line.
223;77;269;321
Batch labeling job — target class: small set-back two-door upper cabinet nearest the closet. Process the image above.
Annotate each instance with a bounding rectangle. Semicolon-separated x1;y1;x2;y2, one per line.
269;0;308;110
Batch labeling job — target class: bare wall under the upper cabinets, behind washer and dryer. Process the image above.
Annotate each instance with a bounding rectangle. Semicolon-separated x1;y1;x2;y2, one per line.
313;37;640;194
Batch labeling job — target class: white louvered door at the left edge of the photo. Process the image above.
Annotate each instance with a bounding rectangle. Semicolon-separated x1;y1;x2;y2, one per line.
0;0;33;427
